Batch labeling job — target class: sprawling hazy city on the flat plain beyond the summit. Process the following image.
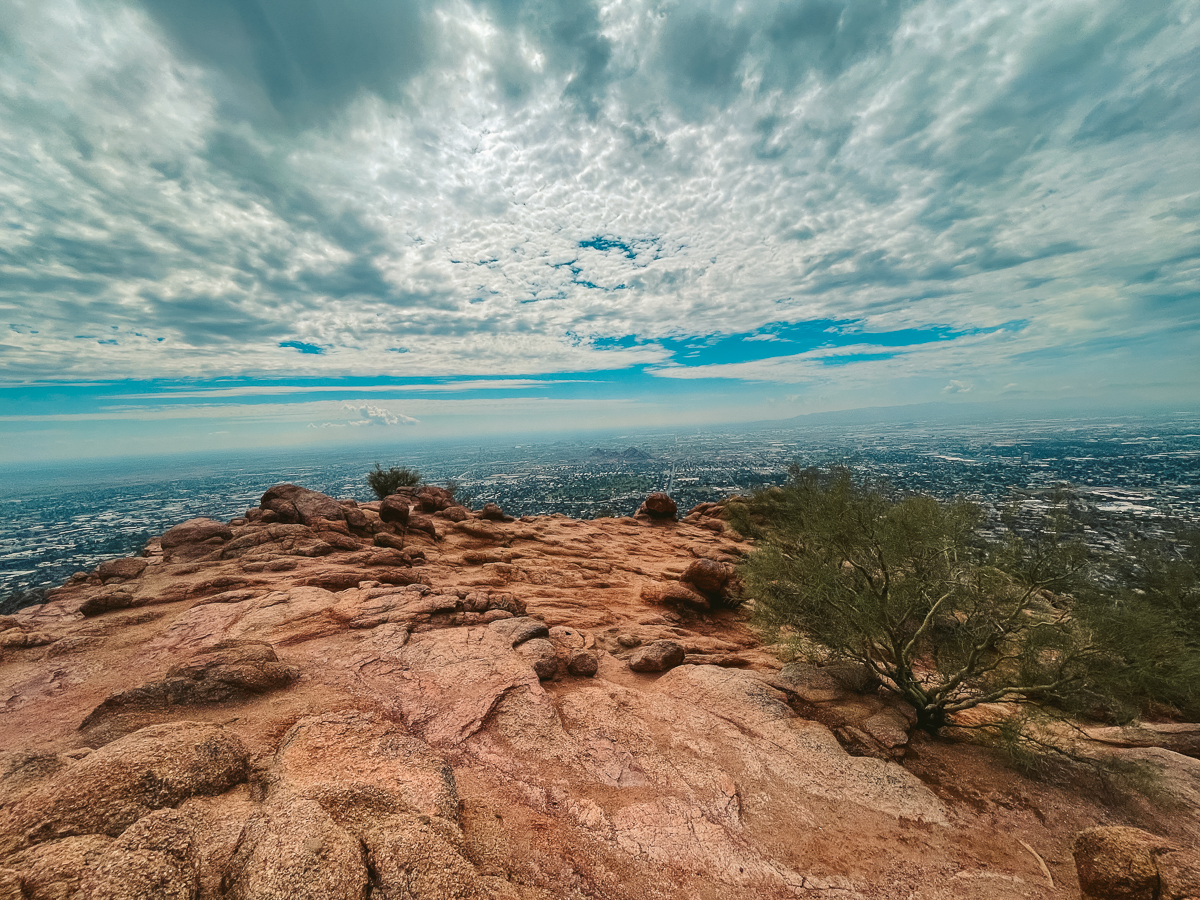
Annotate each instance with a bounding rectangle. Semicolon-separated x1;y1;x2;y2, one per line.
0;414;1200;607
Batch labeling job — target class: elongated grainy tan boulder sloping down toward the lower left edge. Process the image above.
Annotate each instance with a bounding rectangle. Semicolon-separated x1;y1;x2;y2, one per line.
17;722;250;842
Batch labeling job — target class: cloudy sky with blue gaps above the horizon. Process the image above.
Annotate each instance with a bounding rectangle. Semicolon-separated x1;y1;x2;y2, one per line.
0;0;1200;462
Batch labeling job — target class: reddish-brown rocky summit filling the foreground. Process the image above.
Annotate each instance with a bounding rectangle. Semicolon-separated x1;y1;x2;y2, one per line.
0;485;1200;900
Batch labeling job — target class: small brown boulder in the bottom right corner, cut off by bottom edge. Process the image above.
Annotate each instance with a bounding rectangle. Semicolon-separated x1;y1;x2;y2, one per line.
1073;826;1165;900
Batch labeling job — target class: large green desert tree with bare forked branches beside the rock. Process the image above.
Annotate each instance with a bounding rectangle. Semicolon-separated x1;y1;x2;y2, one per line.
734;467;1137;733
